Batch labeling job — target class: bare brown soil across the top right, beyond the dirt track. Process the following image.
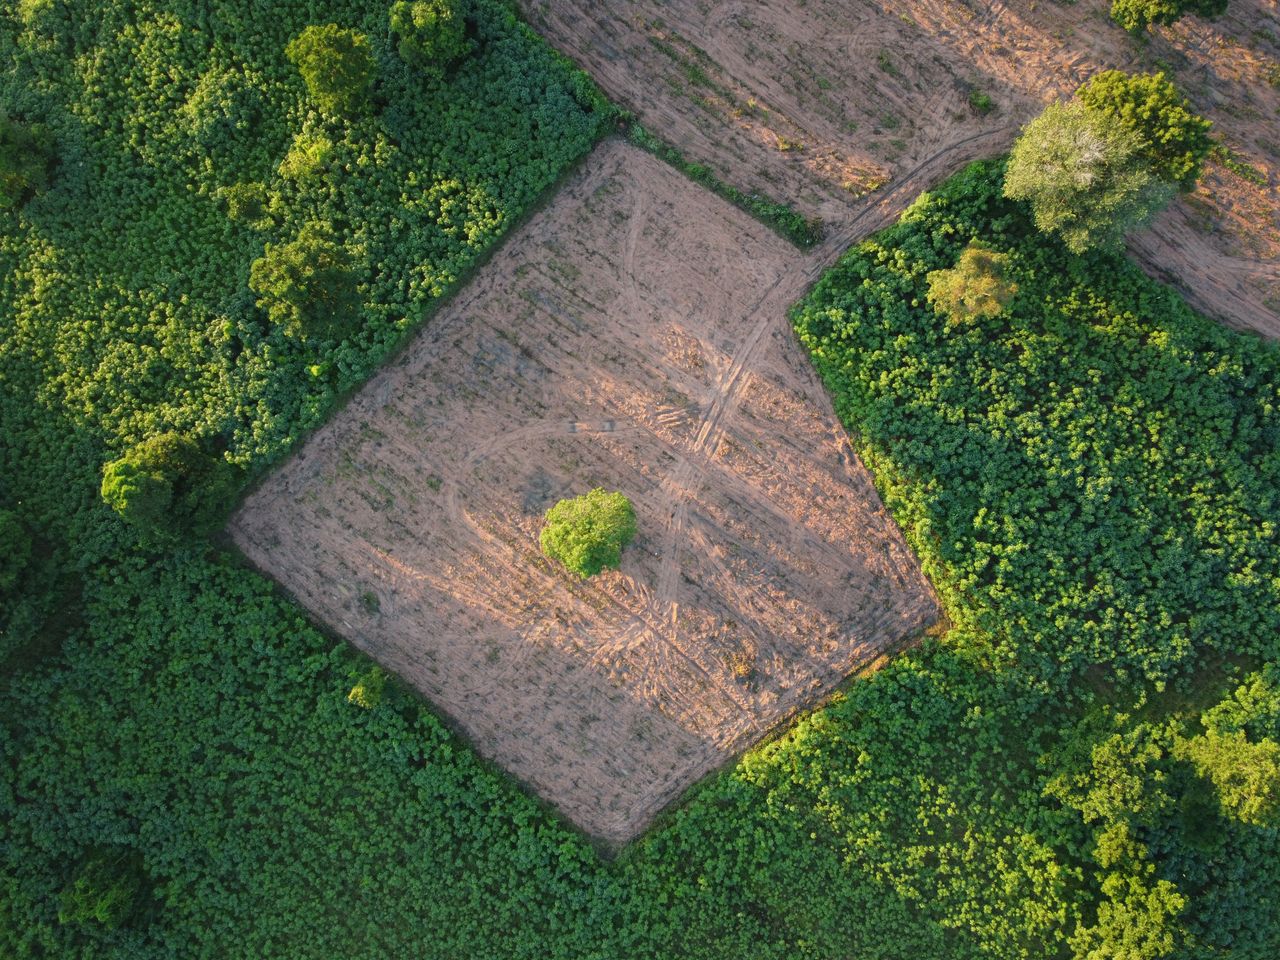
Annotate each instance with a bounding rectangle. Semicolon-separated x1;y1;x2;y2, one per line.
520;0;1280;337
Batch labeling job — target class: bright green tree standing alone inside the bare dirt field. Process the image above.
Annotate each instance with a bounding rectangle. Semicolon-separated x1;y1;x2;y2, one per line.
540;488;636;579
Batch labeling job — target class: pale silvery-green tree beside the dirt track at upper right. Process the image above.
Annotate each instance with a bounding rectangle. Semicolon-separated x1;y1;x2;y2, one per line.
1005;100;1174;253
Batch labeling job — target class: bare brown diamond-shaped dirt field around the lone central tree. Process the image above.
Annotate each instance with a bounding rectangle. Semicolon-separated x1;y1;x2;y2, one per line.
230;141;937;844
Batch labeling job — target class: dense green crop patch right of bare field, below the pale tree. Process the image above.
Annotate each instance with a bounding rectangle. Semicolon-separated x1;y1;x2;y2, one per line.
797;161;1280;681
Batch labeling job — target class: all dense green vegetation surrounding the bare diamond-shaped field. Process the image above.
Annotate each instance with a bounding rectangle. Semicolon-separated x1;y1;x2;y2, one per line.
0;0;1280;960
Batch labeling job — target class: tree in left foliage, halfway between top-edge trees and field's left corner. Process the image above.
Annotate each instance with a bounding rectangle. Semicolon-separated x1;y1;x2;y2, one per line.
248;223;360;339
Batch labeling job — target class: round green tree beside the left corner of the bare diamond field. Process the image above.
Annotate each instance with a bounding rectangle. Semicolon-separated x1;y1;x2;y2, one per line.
101;431;233;543
